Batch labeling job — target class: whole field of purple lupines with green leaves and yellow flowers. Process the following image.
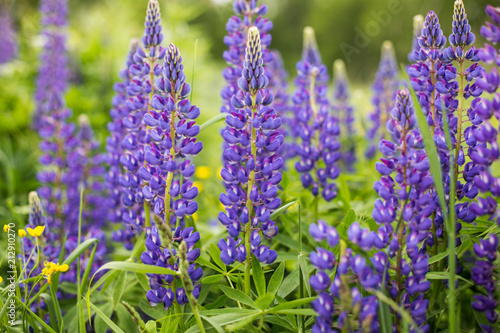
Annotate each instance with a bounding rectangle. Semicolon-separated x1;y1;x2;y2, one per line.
0;0;500;333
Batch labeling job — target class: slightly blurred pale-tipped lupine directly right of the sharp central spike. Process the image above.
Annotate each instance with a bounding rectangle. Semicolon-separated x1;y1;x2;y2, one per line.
290;27;340;201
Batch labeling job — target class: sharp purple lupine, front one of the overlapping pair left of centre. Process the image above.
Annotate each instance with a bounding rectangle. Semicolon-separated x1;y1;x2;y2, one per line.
139;44;203;330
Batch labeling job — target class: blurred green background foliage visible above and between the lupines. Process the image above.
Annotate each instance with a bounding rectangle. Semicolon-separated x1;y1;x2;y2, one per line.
0;0;487;221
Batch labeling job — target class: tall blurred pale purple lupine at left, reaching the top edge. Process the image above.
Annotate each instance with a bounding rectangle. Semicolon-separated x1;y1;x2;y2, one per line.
34;0;80;242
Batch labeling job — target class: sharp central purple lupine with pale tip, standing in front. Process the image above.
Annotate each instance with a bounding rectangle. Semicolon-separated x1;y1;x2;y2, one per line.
218;27;283;296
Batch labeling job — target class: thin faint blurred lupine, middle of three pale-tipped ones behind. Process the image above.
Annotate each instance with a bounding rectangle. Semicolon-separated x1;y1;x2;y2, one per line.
332;60;356;172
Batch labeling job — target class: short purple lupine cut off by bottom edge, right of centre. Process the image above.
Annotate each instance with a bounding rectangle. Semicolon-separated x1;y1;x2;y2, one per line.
309;220;380;332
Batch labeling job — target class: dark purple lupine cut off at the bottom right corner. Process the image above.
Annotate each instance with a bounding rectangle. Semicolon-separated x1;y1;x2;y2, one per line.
472;234;498;326
